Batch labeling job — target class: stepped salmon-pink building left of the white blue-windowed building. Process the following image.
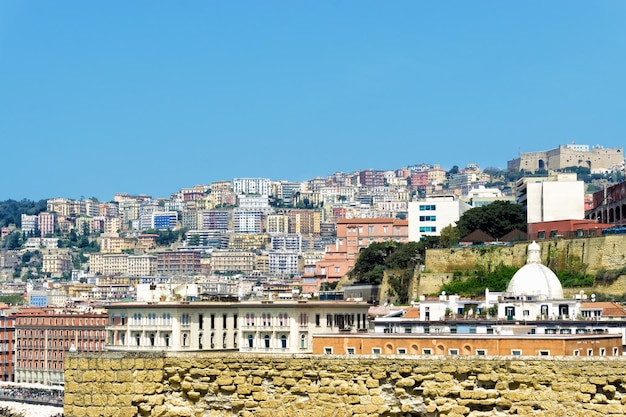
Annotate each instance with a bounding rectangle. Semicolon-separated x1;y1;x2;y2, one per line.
302;218;409;292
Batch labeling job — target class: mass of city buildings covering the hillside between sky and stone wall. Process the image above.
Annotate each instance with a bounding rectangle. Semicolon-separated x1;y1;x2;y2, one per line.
0;144;626;385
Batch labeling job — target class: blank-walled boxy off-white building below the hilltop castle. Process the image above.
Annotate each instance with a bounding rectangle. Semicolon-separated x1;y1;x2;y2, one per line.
515;174;585;223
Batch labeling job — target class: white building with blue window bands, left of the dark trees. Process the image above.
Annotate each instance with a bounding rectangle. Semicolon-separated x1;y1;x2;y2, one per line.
408;196;472;242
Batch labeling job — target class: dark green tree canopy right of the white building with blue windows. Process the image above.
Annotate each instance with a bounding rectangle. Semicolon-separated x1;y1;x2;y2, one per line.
450;201;526;239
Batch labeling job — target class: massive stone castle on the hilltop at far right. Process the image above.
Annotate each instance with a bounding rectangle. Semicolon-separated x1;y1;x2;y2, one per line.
507;142;624;173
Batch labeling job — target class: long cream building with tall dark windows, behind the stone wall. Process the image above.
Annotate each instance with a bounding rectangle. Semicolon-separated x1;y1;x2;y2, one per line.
107;301;369;353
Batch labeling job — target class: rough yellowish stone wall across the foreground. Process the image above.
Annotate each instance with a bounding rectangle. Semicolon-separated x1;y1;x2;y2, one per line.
64;352;626;417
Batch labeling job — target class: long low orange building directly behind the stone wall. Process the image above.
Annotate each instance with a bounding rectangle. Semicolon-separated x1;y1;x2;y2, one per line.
313;333;622;356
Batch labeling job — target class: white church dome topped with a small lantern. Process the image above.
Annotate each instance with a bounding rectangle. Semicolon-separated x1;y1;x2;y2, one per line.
506;242;563;300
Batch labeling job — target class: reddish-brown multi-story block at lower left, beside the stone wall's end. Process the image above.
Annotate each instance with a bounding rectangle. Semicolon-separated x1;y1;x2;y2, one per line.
15;309;107;385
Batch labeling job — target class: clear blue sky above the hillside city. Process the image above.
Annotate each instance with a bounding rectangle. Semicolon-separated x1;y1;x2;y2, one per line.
0;0;626;201
